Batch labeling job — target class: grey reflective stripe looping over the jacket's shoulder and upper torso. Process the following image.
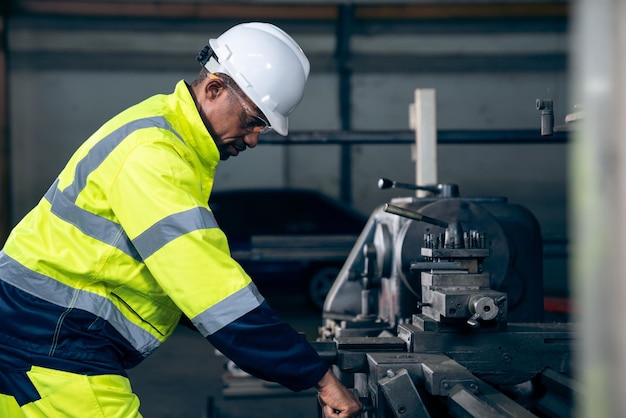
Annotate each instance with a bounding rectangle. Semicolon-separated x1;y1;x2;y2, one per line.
44;116;185;261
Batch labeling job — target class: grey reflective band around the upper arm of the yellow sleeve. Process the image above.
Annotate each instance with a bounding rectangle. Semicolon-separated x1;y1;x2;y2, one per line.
133;207;217;260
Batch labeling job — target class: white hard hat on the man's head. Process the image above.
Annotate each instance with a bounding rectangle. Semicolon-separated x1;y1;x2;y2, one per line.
203;22;310;135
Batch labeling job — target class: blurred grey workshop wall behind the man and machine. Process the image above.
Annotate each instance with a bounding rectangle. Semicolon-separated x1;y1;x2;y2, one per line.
7;4;571;296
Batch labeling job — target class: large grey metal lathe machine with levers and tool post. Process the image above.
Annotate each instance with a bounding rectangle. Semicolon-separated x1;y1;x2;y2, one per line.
314;179;576;418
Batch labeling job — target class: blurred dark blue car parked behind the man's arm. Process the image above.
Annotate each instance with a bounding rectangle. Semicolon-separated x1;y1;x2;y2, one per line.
209;189;367;310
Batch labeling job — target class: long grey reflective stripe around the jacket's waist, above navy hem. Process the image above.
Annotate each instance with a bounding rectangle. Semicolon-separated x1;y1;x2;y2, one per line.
0;251;161;357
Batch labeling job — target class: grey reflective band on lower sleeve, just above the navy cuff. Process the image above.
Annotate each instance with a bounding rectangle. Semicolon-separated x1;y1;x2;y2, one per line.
191;282;265;337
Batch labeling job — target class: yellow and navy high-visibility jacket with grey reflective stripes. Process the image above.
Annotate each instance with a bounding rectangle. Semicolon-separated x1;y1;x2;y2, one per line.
0;81;327;398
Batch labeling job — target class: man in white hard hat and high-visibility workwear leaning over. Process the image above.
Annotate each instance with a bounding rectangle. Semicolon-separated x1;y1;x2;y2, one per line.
0;23;361;418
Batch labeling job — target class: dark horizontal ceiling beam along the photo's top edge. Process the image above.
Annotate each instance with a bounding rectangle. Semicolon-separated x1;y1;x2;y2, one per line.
9;0;569;20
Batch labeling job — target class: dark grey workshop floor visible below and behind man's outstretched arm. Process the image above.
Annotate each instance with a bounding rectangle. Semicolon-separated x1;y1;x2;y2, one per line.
128;288;321;418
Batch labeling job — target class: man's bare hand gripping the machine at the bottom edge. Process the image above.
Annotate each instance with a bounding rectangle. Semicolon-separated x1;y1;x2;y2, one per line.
317;370;362;418
